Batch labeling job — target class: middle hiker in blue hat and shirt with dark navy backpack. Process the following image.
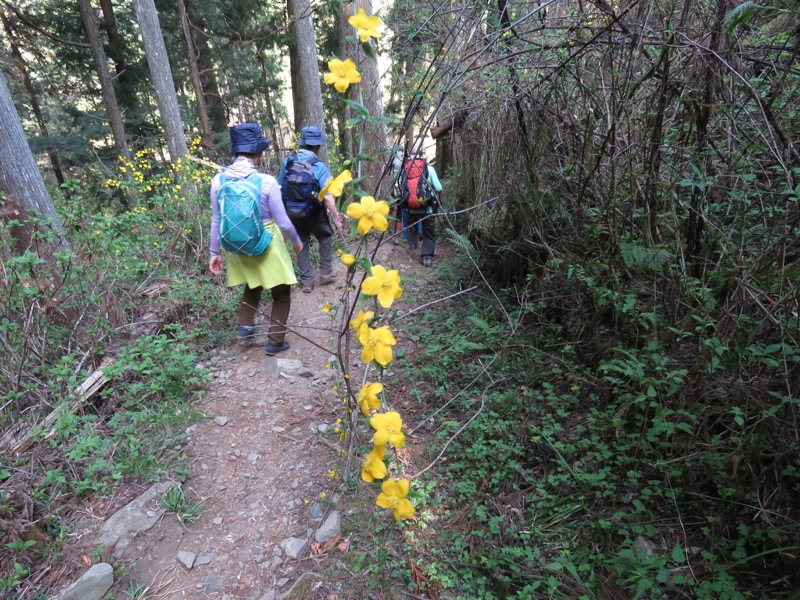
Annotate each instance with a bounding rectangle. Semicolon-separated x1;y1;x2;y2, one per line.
278;125;342;294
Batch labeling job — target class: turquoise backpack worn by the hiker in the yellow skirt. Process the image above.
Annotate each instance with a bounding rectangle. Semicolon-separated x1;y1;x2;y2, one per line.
217;172;272;256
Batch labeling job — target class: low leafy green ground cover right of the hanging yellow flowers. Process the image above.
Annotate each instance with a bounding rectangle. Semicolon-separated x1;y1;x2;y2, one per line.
368;233;800;599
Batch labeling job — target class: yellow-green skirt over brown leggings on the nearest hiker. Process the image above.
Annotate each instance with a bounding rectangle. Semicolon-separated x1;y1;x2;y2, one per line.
226;221;297;289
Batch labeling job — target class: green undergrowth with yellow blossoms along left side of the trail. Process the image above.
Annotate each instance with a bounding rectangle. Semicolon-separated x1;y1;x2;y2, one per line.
0;151;235;598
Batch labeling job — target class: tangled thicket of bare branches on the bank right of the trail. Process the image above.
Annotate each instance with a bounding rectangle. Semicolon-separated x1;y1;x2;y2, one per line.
392;0;800;597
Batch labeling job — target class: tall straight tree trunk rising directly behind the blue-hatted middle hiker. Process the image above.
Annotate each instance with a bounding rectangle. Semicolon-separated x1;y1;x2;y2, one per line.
287;0;328;162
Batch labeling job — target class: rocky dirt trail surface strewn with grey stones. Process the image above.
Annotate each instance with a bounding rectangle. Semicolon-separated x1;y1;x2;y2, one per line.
55;245;438;600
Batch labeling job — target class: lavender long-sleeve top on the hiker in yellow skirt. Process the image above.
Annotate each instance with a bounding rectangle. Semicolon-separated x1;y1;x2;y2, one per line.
209;156;300;257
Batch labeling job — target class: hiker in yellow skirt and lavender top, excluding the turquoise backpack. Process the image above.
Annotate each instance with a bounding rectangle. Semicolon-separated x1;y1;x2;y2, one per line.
208;123;303;356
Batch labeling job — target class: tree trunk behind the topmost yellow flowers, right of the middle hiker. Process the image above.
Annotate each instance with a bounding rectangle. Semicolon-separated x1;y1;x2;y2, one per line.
338;0;394;197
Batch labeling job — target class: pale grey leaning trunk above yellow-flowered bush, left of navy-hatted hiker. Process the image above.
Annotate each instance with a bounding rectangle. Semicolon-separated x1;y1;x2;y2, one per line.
133;0;189;160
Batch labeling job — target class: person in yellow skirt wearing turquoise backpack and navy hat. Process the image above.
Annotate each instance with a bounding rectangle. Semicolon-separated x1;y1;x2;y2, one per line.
208;123;303;355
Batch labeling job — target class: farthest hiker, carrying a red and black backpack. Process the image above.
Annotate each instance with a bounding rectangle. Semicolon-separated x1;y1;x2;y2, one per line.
398;150;442;267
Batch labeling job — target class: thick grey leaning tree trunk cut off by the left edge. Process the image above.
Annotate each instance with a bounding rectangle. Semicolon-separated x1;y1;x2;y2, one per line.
0;71;61;231
